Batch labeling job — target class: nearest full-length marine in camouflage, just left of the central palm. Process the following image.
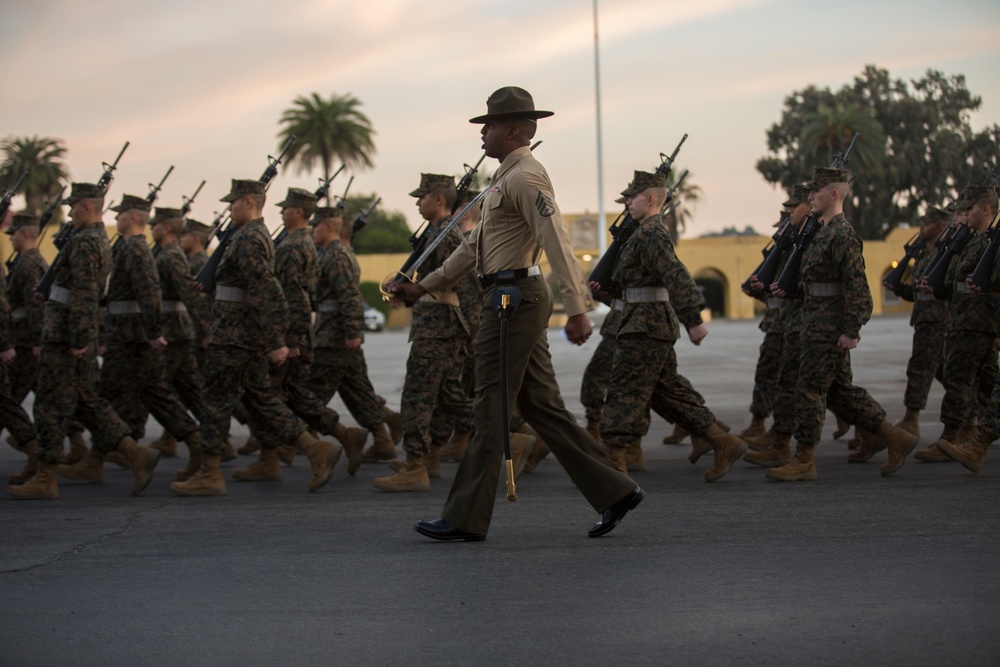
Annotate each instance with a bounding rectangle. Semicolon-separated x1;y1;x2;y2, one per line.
170;179;342;496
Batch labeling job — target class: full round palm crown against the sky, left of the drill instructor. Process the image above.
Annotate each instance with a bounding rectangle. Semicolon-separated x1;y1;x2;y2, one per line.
278;93;375;203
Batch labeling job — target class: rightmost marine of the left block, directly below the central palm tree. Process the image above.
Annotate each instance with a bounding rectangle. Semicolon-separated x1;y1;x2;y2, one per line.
309;206;399;460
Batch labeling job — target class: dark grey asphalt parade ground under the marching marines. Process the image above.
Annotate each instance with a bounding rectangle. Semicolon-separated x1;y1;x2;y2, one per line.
0;317;1000;666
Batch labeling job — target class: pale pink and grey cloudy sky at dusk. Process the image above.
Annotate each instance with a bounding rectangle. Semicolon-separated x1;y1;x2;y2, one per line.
0;0;1000;236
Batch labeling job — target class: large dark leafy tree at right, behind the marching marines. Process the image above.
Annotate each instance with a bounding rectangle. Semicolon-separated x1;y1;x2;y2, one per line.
757;65;1000;239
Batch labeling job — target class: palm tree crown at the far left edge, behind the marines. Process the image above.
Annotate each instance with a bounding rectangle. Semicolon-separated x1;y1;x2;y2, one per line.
0;136;69;215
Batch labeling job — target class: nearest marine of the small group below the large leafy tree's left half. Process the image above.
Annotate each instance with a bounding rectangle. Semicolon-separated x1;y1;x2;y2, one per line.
767;168;917;481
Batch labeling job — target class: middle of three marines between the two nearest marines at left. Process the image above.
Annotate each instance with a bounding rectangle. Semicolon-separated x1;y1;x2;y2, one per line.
151;208;211;472
